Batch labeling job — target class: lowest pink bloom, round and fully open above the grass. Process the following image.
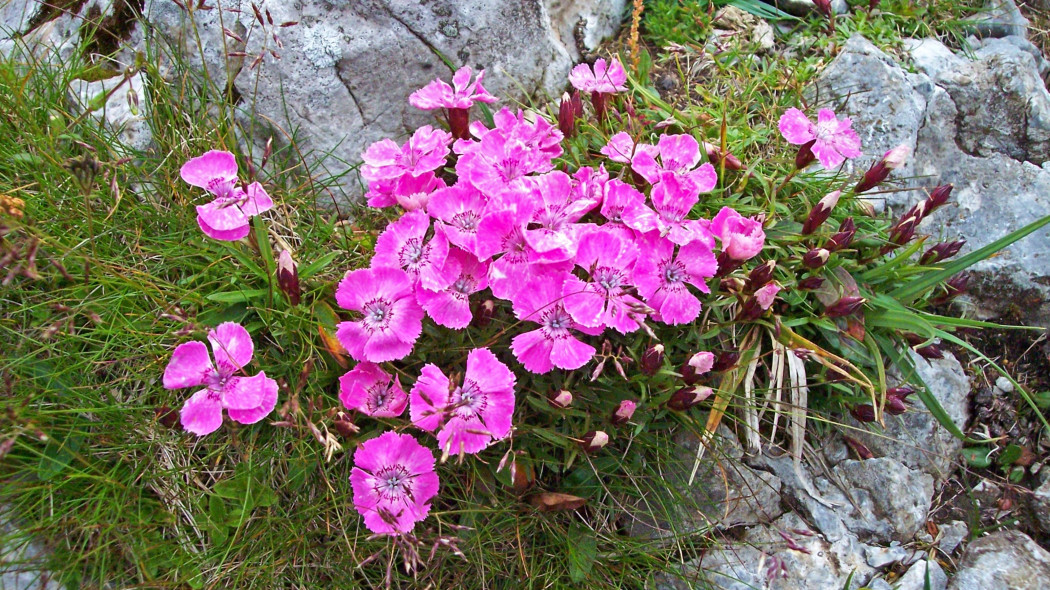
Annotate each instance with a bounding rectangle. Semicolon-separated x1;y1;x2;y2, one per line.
350;431;439;535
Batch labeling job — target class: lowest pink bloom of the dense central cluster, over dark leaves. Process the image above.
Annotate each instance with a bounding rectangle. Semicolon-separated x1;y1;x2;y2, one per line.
510;272;601;374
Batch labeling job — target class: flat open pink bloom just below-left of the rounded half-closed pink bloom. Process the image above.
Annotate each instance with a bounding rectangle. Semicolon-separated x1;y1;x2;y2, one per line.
634;233;718;325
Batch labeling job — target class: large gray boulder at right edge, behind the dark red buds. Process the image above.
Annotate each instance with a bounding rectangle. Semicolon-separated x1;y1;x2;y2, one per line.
815;36;1050;325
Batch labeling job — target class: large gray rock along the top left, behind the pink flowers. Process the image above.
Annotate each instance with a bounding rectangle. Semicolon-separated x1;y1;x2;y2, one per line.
0;0;626;196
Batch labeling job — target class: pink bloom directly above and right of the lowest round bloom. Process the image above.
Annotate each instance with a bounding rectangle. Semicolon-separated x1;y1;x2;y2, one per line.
411;349;515;455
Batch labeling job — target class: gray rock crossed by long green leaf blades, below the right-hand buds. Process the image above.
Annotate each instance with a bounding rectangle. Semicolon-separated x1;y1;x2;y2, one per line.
854;353;970;482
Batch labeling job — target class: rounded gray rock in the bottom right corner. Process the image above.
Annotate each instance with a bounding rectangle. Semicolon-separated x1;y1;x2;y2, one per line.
948;530;1050;590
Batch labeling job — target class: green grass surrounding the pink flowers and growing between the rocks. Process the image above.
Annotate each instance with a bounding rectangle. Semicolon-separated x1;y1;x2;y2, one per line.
0;1;1016;588
